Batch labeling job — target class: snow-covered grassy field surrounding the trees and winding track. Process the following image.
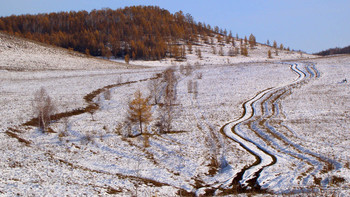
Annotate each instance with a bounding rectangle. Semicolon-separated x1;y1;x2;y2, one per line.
0;33;350;196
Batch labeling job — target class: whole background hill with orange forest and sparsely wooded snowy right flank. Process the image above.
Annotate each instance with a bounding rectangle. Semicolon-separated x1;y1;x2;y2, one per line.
0;6;314;62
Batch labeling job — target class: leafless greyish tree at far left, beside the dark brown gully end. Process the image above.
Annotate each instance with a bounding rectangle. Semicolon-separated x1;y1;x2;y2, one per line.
33;87;56;132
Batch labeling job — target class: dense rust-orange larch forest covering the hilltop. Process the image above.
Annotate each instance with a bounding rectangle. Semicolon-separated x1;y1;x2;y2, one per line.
0;6;217;60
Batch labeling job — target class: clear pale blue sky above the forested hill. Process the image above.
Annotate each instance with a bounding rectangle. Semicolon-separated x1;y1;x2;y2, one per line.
0;0;350;53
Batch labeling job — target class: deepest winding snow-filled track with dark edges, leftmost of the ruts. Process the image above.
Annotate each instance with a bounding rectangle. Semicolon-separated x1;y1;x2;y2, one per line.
221;64;312;192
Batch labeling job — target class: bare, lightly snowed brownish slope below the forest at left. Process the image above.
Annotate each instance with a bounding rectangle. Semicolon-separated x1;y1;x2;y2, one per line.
0;32;126;70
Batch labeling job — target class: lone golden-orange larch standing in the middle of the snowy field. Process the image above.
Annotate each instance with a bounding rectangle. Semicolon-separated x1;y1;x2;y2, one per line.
128;90;152;134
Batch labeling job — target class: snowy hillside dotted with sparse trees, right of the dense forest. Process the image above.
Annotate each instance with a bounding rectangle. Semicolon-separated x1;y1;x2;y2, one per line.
126;36;317;66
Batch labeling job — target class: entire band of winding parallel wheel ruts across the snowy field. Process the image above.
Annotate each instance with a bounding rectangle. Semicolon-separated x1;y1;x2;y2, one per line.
216;63;339;194
